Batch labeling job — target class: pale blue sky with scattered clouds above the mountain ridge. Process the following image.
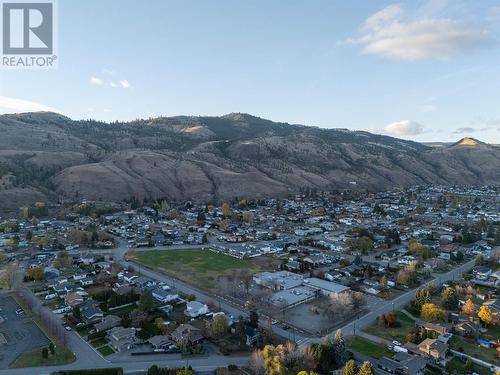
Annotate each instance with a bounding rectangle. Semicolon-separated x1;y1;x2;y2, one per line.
0;0;500;144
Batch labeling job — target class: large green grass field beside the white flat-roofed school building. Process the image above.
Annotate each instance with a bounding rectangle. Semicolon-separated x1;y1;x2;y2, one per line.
128;249;261;290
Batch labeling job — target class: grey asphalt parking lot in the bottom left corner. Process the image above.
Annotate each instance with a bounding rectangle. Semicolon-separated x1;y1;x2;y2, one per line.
0;296;49;369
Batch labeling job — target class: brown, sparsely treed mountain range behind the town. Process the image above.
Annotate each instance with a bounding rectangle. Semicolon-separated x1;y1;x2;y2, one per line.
0;112;500;211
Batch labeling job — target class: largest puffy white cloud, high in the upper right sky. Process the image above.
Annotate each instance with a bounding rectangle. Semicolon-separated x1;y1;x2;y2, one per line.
341;1;488;61
